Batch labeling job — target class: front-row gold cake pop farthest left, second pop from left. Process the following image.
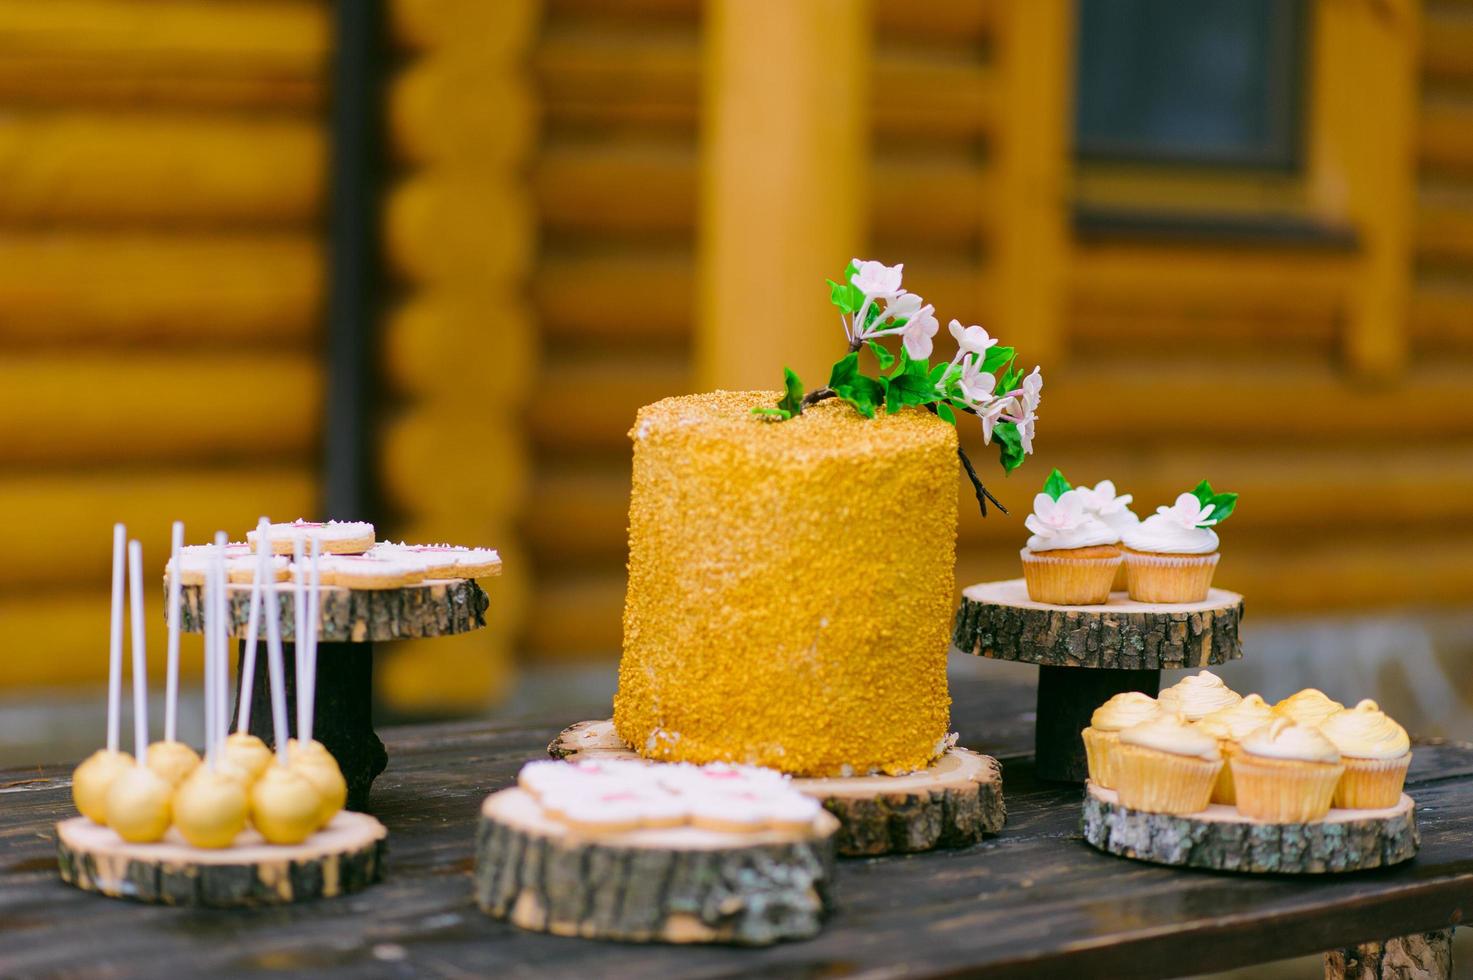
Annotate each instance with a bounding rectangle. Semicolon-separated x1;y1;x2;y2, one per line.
106;541;174;843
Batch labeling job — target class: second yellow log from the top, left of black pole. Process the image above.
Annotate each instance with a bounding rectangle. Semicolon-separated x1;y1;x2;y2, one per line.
0;112;326;224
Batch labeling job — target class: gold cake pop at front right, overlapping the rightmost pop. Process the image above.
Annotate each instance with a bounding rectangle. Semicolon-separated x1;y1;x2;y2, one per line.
250;519;323;844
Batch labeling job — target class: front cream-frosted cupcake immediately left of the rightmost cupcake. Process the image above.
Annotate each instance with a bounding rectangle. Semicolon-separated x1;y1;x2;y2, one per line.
1228;718;1345;824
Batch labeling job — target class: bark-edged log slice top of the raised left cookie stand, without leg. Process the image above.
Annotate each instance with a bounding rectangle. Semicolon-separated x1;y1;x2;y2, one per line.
171;579;491;643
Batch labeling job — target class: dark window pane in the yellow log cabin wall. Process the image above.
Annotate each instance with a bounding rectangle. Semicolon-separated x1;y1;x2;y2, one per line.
1074;0;1307;171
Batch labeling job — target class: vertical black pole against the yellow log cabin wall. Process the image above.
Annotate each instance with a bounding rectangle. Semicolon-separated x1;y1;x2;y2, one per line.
323;0;383;520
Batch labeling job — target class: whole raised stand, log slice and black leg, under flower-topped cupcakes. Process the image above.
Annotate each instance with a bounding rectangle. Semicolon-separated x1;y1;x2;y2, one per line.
952;579;1243;783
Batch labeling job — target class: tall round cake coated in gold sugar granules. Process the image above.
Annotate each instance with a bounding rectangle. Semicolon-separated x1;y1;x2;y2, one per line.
614;392;957;777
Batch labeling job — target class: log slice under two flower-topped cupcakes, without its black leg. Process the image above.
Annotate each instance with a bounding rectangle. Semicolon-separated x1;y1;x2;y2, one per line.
952;579;1243;671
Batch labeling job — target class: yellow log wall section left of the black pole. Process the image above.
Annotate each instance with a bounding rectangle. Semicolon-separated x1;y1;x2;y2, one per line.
0;0;328;686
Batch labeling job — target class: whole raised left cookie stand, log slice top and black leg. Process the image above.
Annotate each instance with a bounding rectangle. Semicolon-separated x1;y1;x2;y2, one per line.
180;579;489;811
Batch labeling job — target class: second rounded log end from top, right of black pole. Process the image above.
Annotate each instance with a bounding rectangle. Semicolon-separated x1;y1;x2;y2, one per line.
387;49;538;171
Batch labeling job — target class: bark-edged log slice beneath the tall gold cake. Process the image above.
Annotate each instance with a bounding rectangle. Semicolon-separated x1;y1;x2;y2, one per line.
548;719;1008;858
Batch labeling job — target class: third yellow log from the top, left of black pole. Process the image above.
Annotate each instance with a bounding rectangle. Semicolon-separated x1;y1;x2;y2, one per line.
0;231;323;345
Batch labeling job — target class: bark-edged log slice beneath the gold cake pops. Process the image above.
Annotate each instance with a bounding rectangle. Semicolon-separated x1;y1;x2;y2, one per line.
56;811;387;908
